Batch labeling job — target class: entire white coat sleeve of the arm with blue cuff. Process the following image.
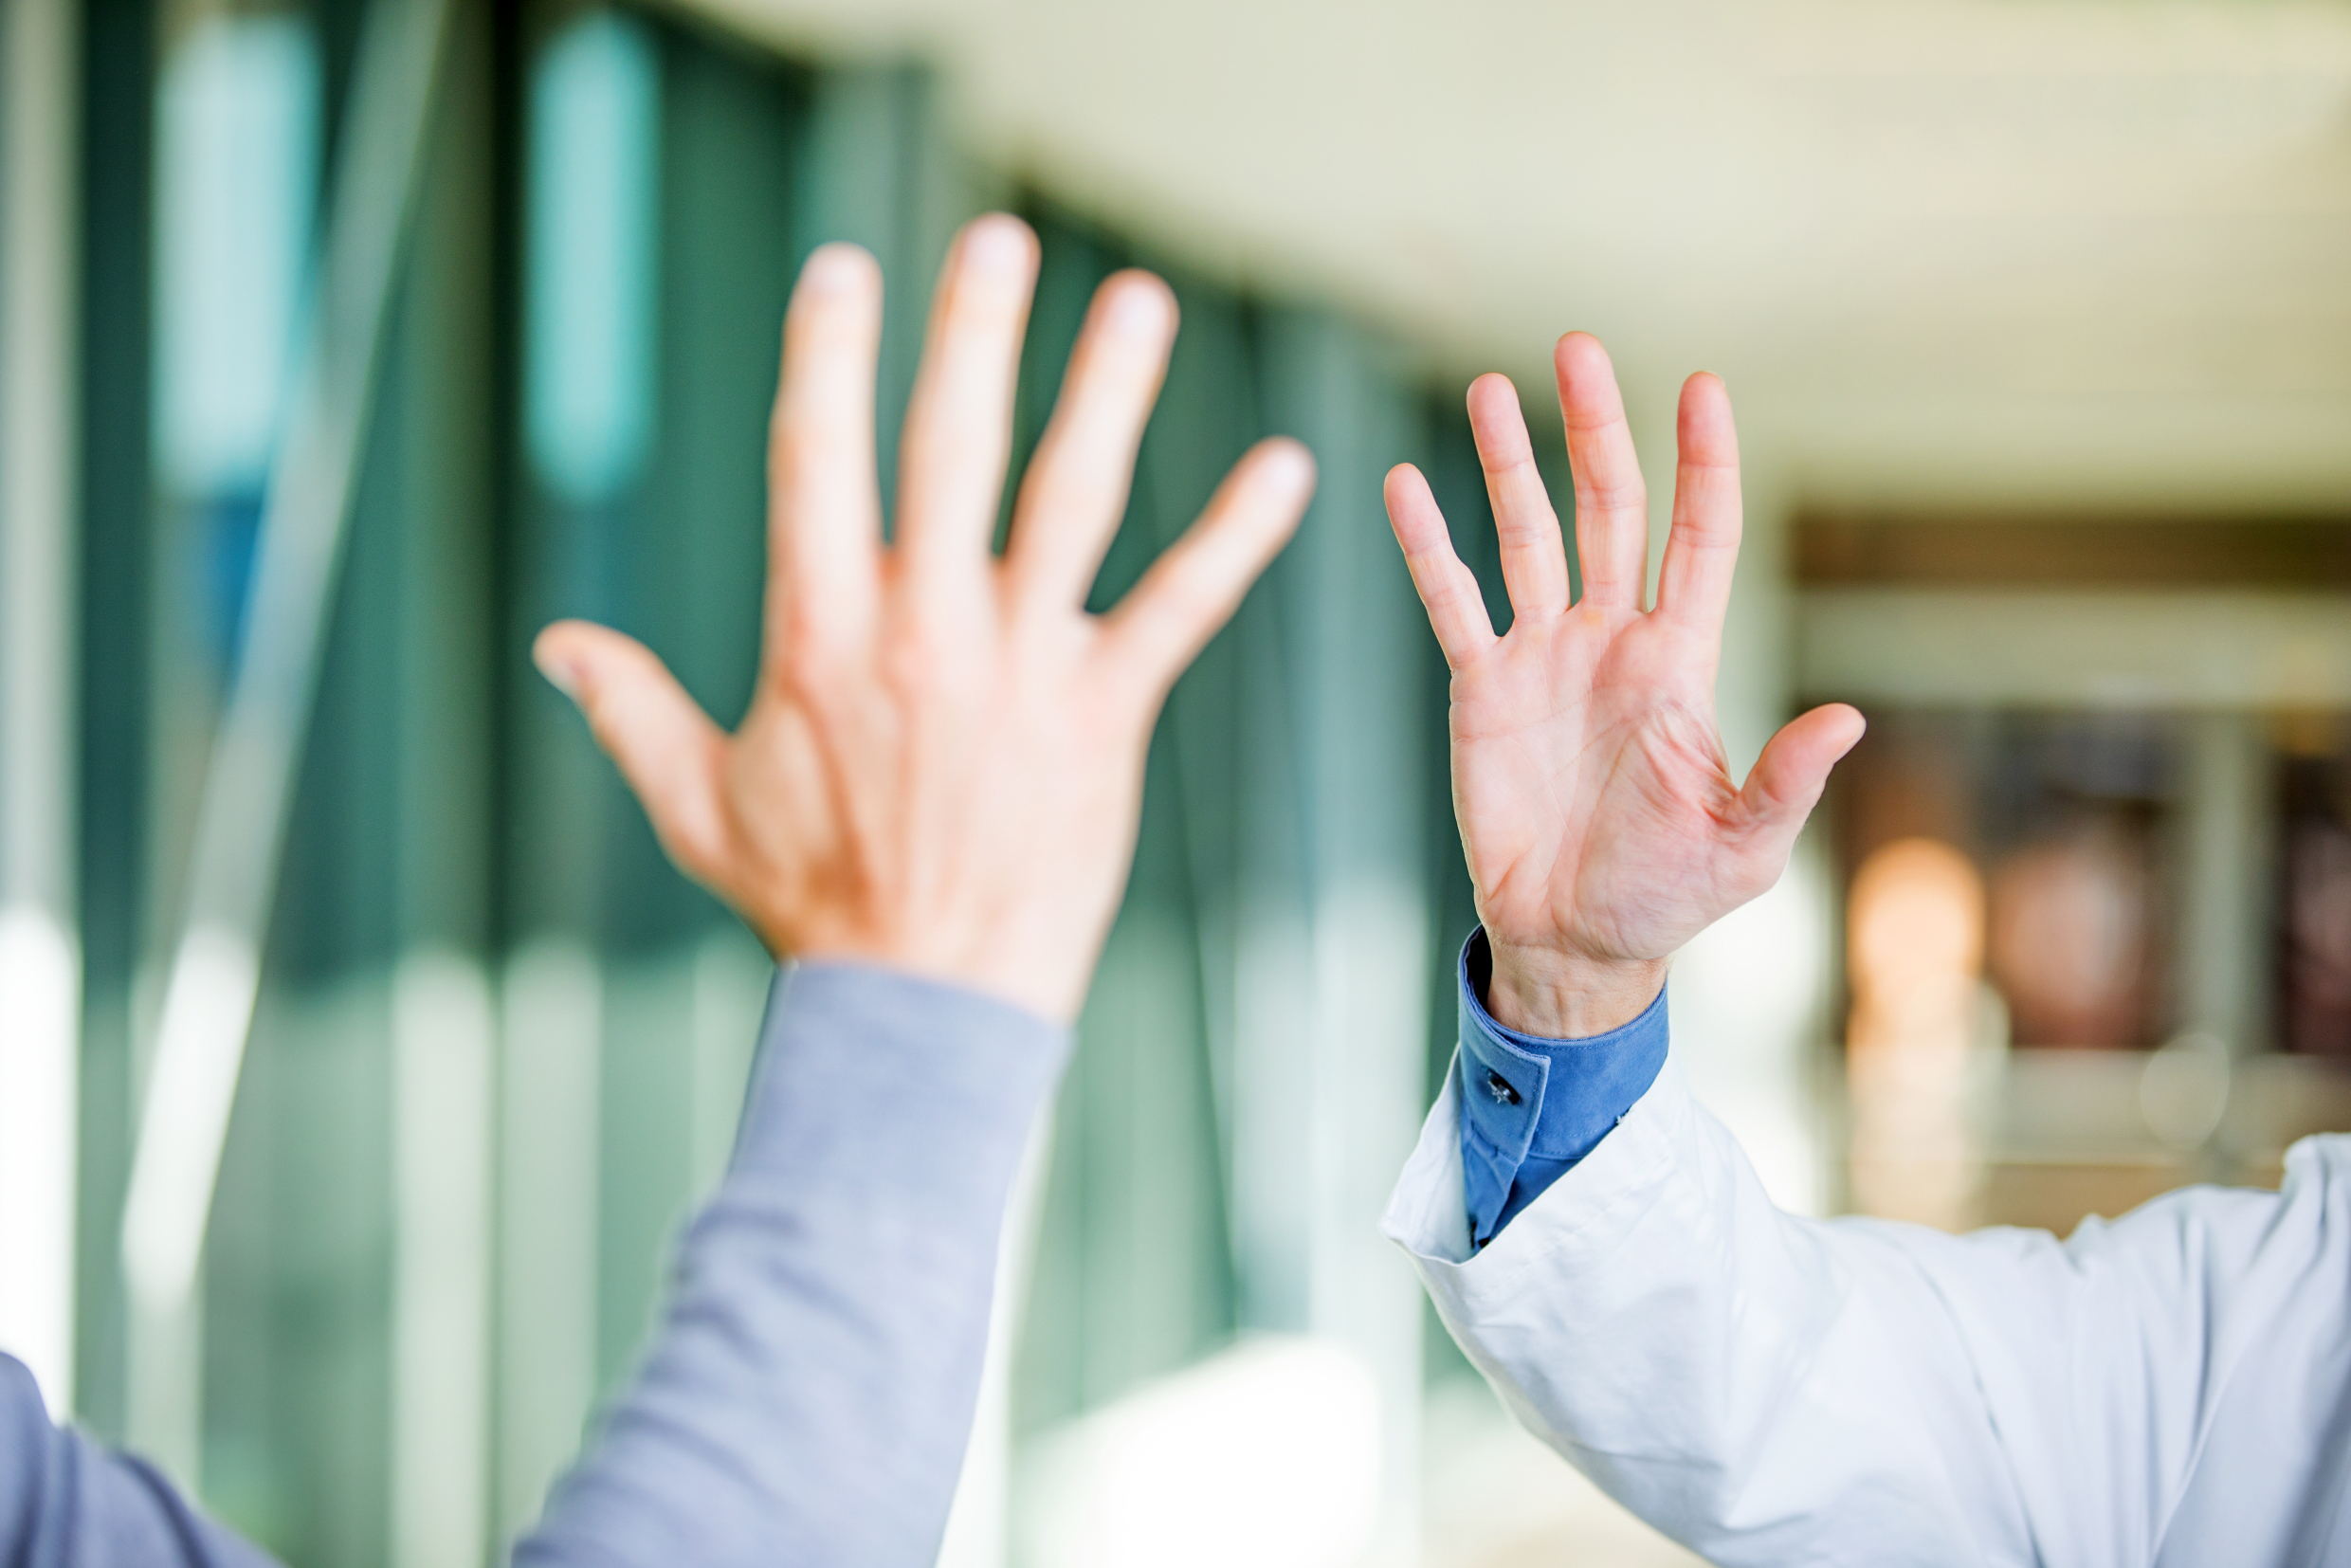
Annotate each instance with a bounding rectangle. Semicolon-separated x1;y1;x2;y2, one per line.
1385;1063;2351;1568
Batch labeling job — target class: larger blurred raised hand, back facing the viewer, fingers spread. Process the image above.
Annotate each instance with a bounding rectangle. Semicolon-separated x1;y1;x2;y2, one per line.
536;214;1314;1020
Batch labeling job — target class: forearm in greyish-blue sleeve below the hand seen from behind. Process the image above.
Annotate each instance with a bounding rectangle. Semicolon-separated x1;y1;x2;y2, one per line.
515;966;1067;1568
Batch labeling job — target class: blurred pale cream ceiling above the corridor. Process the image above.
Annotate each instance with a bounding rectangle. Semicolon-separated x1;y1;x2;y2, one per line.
677;0;2351;518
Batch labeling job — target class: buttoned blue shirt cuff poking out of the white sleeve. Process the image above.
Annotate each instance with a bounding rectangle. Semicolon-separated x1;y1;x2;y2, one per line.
1453;926;1669;1246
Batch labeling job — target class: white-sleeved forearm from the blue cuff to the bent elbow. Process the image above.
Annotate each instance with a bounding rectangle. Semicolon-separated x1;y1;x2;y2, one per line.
1387;1065;2024;1563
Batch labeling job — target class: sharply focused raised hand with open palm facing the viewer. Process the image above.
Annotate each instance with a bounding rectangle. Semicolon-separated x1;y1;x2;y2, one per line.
1387;332;1862;1037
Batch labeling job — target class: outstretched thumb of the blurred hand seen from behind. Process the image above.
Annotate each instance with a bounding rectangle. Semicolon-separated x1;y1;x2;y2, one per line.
531;621;726;879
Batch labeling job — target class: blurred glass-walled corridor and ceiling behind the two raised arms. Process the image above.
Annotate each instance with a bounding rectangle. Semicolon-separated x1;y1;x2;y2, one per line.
0;0;2351;1568
